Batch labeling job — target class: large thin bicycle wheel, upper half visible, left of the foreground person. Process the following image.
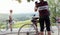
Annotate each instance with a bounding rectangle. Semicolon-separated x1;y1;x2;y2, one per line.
18;24;36;35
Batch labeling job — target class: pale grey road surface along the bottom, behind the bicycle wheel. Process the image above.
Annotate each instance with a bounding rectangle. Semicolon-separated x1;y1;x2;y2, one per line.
0;26;58;35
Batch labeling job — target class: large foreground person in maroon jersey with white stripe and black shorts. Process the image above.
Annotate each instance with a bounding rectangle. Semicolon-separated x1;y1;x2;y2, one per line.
34;0;51;35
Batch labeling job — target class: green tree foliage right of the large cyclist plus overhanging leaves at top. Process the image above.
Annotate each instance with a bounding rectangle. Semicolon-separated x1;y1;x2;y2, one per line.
17;0;60;22
